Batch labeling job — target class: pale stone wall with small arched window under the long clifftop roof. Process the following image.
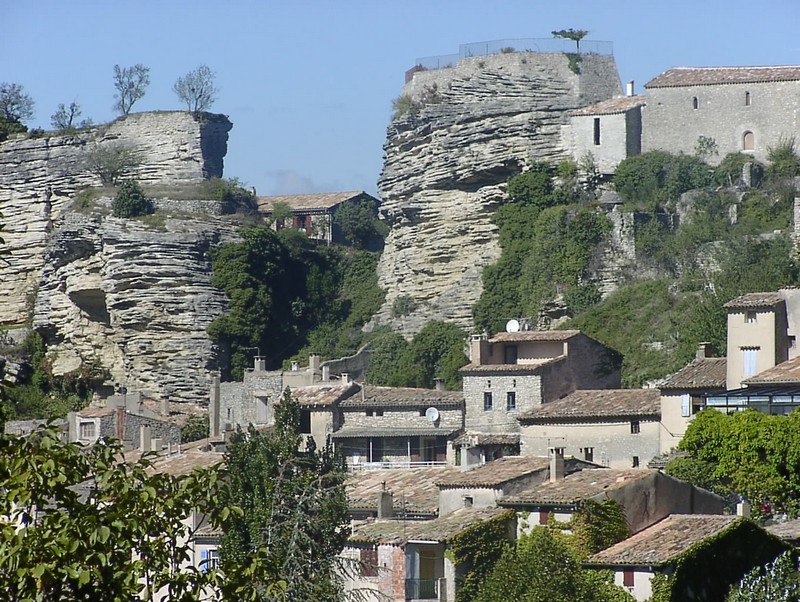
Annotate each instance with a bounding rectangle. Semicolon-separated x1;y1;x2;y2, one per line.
642;81;800;163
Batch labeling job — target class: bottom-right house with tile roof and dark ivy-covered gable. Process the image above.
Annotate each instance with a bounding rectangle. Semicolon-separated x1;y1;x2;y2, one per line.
584;514;789;601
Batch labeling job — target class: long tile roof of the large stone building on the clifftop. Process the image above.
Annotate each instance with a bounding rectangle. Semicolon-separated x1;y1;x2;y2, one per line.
644;65;800;88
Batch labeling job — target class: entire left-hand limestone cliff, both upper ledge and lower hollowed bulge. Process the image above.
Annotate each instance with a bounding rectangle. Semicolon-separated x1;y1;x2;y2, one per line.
0;112;236;402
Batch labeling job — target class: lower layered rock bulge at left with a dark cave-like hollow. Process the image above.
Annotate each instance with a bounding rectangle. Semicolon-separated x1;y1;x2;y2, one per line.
33;212;236;402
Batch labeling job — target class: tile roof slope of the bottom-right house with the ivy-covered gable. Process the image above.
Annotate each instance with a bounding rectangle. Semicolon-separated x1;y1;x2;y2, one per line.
587;514;744;566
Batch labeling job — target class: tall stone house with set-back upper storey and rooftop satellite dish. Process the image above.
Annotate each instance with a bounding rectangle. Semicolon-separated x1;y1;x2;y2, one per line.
461;330;622;464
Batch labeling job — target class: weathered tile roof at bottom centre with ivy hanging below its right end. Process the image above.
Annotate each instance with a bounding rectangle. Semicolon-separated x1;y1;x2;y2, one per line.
350;508;514;545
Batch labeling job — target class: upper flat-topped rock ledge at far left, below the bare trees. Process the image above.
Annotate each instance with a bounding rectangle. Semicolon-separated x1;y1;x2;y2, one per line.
0;111;232;325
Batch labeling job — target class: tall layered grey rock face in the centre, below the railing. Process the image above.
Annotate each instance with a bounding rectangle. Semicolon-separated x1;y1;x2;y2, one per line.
372;52;621;336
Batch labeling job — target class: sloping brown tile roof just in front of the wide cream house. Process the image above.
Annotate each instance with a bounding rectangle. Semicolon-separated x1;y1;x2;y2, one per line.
500;468;659;506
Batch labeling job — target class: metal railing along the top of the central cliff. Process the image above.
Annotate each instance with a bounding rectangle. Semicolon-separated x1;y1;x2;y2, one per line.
410;38;614;71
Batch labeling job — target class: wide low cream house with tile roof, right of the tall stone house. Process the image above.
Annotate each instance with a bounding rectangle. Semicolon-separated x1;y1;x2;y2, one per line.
519;389;661;468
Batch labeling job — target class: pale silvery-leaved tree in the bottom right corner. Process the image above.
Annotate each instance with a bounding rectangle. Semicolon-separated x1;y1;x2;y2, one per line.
726;552;800;602
